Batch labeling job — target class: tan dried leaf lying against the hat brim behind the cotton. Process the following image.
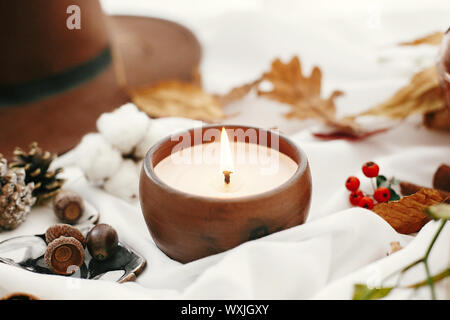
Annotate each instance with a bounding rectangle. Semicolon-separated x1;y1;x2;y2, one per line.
131;80;224;122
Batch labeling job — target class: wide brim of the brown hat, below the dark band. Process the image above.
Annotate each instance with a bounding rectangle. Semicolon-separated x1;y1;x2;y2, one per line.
0;16;201;158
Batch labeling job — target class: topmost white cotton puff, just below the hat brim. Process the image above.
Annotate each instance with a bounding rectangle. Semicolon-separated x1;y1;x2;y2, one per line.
97;103;150;154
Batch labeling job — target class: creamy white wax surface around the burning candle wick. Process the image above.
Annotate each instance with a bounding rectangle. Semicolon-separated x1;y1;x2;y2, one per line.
154;142;298;198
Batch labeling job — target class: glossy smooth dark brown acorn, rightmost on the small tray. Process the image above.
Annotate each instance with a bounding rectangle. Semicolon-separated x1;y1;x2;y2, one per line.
86;223;119;261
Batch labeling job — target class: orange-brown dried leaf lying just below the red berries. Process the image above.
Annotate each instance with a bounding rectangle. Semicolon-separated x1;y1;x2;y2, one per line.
372;188;443;234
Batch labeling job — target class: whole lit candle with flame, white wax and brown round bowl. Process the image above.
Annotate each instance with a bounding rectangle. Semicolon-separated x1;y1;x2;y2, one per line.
139;125;312;263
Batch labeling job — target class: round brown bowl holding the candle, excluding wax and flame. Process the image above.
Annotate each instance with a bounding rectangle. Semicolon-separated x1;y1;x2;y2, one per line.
139;125;312;263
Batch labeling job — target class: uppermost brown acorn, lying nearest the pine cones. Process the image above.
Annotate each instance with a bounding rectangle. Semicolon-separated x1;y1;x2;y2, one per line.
53;190;85;224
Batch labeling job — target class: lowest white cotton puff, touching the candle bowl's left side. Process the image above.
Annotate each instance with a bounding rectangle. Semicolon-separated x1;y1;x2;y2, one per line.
103;159;139;200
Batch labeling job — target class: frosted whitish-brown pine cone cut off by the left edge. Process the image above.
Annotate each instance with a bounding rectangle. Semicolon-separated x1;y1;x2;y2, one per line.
0;154;36;230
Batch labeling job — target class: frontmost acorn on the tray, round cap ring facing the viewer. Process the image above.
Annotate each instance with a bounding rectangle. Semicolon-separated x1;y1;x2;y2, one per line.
44;236;84;275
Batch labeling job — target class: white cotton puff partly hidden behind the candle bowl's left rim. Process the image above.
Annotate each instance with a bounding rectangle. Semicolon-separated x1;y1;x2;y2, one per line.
134;117;203;158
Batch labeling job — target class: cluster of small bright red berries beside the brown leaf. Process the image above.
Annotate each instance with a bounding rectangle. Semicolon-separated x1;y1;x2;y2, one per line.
345;161;398;209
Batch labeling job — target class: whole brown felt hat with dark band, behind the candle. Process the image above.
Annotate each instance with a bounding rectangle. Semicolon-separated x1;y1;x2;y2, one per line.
0;0;201;157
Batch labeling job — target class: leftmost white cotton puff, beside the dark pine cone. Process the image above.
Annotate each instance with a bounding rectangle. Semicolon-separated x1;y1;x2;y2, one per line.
77;133;123;185
